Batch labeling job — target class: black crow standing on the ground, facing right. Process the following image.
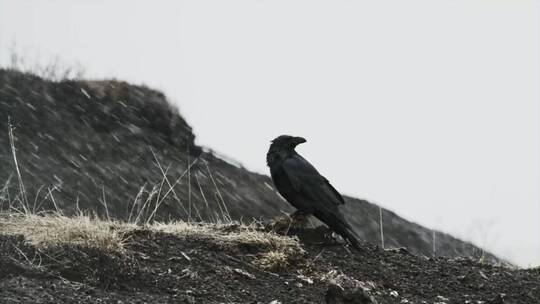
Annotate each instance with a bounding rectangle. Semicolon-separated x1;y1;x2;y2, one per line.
266;135;360;248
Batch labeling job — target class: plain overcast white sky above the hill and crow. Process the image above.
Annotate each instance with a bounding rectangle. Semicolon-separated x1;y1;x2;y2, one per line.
0;0;540;266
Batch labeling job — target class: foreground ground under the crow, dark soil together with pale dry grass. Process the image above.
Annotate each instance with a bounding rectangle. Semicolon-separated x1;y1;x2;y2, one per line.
0;215;540;304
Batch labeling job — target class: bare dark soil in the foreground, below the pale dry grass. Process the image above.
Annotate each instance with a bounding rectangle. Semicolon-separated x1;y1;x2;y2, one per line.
0;228;540;304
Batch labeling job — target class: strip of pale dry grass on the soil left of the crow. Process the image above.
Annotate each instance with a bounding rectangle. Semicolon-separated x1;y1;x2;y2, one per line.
0;213;304;271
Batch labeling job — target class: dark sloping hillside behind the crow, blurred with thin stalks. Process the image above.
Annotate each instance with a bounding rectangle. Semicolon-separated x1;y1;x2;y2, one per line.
0;69;497;261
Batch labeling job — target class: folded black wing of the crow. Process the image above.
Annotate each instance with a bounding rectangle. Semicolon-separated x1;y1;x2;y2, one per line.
282;154;345;205
